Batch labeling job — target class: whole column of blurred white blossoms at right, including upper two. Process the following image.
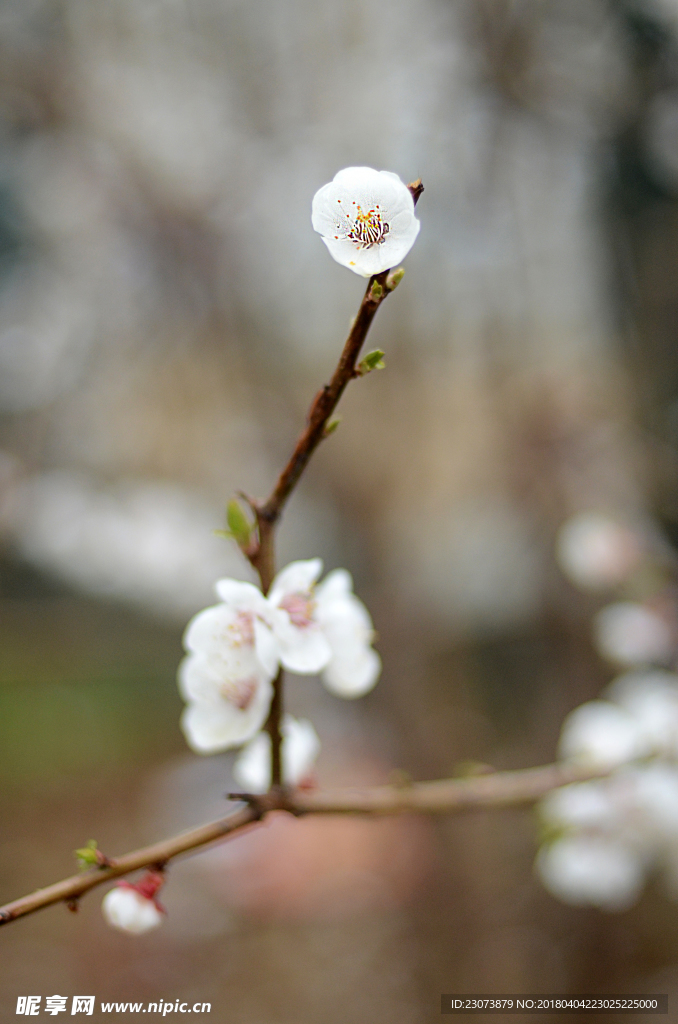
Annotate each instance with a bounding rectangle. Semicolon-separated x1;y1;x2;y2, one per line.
536;513;678;910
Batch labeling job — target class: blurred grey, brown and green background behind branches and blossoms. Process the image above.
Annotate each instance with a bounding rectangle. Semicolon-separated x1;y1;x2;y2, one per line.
0;0;678;1024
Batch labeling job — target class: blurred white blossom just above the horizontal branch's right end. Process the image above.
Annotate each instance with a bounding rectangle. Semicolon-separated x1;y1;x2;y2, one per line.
558;700;649;770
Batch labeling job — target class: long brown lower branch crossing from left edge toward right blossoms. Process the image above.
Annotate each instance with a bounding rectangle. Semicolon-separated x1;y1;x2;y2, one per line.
0;764;607;925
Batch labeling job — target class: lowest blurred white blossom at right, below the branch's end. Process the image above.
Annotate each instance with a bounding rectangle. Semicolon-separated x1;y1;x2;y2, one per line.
535;835;644;910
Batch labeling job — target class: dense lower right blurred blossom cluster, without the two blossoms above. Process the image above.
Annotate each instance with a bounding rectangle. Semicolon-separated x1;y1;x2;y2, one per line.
537;670;678;910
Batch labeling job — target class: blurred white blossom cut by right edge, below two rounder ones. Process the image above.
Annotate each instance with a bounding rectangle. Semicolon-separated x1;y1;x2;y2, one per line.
606;669;678;758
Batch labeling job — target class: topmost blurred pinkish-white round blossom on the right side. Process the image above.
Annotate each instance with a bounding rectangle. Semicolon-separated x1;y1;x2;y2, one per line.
556;512;640;590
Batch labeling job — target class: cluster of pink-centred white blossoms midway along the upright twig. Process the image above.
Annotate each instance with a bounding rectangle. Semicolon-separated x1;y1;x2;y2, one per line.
179;558;381;754
